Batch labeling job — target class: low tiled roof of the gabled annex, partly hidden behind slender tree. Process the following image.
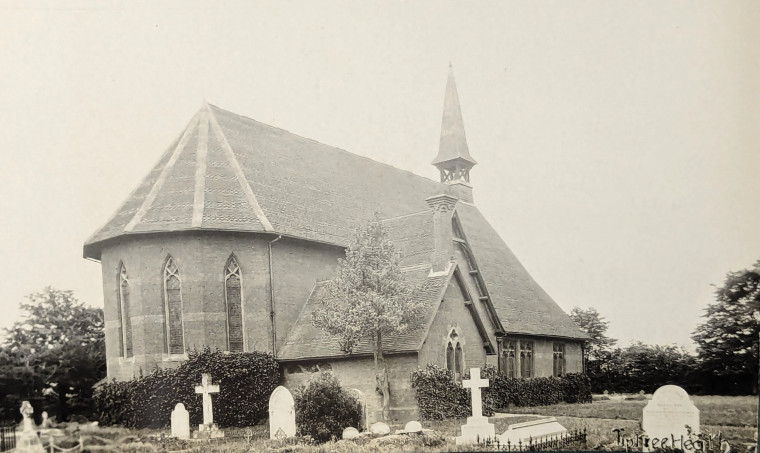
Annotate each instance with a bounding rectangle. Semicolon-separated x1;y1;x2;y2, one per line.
277;265;455;360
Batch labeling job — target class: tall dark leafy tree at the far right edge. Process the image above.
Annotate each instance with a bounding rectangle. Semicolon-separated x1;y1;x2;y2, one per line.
692;261;760;393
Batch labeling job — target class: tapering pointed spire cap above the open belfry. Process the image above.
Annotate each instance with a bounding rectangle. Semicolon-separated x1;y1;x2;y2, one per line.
432;62;477;166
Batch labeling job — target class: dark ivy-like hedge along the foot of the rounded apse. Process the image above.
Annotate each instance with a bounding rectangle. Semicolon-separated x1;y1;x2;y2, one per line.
94;349;280;428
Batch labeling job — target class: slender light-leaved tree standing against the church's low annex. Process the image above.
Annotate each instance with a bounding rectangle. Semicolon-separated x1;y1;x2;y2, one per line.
312;215;423;420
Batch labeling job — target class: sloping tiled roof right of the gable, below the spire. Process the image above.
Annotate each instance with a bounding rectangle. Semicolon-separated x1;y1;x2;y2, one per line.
456;203;588;339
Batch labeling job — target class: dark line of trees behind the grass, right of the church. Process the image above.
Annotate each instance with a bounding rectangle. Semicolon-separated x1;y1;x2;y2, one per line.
570;261;760;395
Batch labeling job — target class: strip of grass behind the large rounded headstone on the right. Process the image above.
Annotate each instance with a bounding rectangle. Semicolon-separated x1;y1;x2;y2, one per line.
508;396;757;427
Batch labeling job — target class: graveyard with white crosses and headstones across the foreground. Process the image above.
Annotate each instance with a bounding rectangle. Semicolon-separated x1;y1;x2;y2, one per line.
2;368;757;453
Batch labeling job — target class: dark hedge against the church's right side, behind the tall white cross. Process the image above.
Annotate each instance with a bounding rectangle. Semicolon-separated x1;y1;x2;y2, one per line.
412;365;591;420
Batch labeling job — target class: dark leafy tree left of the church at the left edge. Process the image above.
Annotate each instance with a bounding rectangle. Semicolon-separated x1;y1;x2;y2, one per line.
0;287;105;418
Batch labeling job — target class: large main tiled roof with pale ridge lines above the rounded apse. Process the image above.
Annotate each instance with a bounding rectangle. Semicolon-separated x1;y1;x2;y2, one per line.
84;105;444;259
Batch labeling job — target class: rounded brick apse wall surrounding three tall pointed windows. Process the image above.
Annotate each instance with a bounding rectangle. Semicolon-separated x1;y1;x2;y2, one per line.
101;232;343;380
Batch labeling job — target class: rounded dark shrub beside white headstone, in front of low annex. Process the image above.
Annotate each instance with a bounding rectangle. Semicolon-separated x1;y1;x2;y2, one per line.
293;372;361;442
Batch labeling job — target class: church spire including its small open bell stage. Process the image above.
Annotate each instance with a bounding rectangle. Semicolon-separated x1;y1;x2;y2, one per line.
432;63;477;182
